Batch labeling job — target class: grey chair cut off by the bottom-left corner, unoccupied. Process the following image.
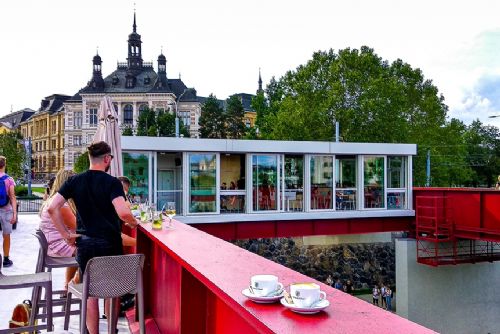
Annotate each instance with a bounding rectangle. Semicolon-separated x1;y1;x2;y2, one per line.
0;255;53;334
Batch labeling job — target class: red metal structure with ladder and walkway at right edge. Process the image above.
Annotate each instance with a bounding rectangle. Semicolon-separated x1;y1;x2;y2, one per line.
414;188;500;266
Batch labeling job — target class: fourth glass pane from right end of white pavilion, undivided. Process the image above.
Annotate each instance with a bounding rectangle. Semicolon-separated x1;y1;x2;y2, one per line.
310;156;333;210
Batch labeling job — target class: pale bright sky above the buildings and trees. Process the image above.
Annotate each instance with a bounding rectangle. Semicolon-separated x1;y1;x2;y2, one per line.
0;0;500;126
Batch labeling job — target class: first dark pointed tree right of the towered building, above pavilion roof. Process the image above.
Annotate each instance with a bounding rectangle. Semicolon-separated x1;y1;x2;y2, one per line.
199;94;226;138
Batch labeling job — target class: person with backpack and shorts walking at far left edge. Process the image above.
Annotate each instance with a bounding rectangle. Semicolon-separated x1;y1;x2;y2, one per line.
0;156;17;268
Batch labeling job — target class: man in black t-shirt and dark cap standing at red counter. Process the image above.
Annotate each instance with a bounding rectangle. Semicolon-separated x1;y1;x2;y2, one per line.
48;142;138;334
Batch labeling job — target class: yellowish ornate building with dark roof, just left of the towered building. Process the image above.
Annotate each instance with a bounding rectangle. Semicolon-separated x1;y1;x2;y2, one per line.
20;94;70;179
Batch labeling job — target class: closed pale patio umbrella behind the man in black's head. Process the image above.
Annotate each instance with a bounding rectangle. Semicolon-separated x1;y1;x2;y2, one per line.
92;95;123;176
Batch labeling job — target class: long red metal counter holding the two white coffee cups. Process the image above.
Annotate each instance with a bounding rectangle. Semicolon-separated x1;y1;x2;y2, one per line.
131;221;433;334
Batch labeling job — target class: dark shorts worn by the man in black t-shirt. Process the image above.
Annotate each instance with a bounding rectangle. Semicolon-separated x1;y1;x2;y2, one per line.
76;236;123;275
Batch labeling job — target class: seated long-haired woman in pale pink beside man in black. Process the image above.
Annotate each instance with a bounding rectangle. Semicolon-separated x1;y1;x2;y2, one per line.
40;170;78;288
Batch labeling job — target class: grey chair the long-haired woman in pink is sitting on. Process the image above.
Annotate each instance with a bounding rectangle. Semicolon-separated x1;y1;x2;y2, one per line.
31;230;79;321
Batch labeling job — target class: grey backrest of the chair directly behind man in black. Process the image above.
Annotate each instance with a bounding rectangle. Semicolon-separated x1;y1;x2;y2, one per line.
83;254;144;298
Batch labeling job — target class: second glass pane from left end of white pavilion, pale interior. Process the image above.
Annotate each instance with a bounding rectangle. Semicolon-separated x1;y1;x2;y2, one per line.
156;152;182;214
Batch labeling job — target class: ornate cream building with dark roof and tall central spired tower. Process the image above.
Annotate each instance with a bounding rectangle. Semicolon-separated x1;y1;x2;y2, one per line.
64;13;201;169
